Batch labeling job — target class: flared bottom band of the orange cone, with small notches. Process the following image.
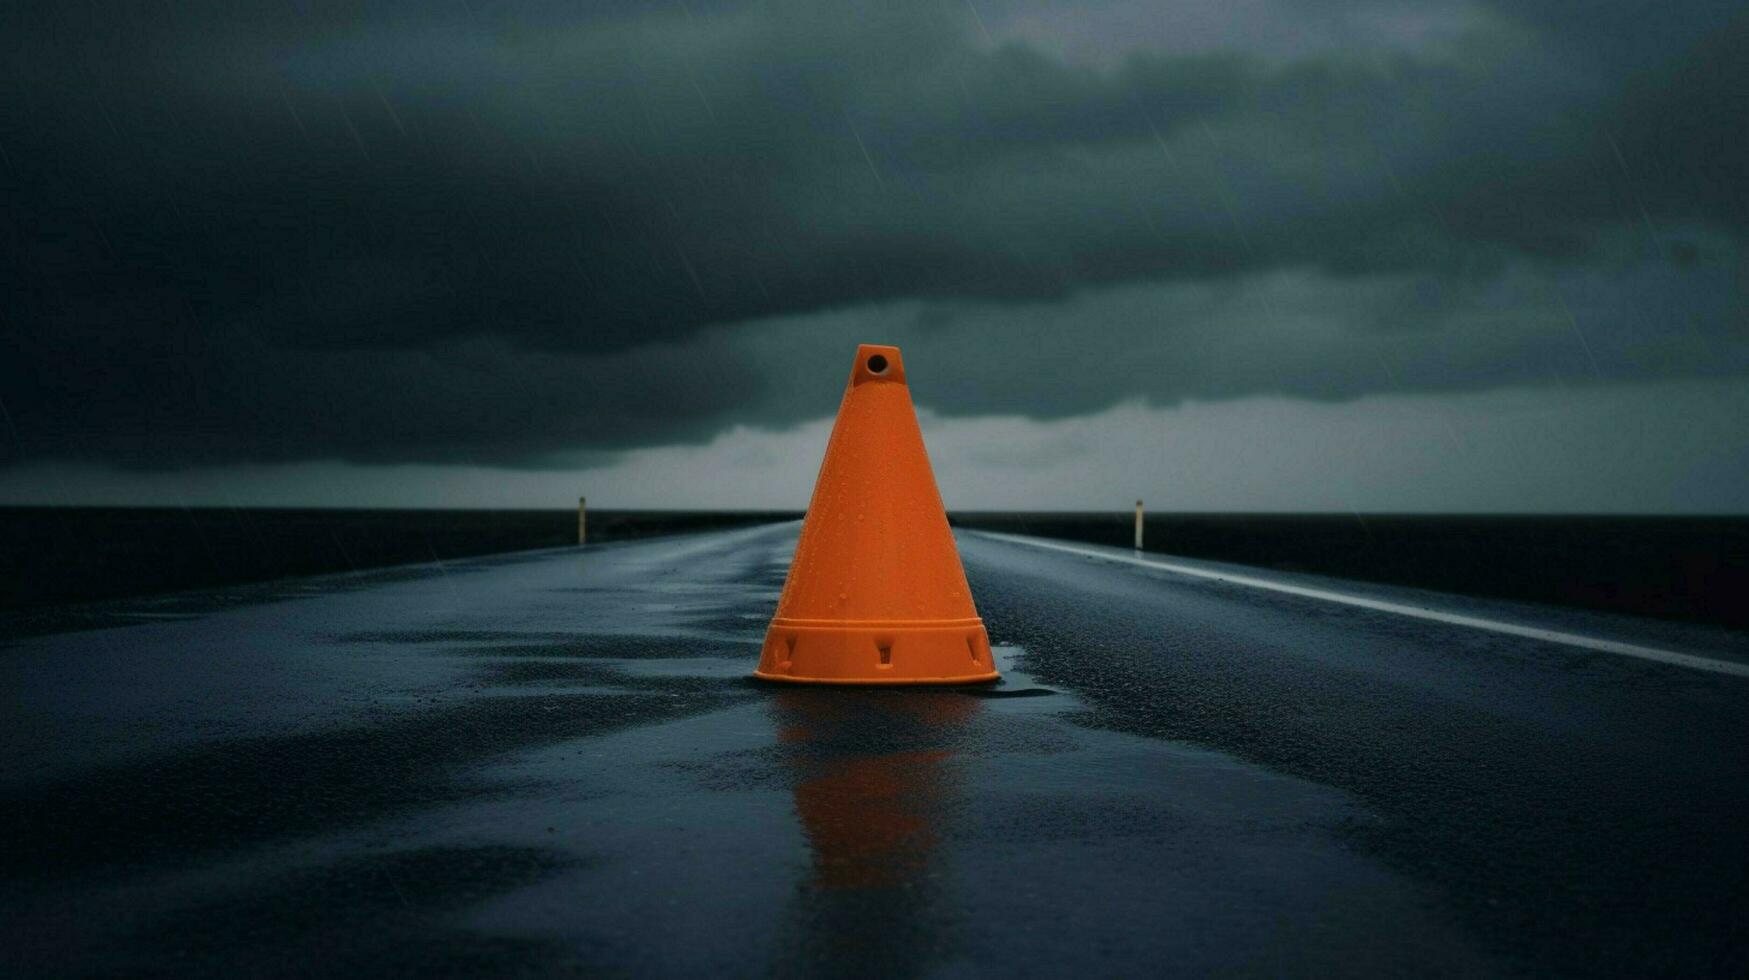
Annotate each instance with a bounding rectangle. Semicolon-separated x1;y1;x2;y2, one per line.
754;616;1002;684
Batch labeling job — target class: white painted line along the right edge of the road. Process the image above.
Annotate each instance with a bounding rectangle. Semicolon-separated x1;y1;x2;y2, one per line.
972;530;1749;677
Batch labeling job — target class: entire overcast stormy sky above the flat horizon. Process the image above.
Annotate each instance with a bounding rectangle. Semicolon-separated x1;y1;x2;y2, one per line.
0;0;1749;511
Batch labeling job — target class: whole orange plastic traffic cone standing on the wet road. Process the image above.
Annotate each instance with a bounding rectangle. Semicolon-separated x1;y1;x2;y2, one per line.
754;343;999;684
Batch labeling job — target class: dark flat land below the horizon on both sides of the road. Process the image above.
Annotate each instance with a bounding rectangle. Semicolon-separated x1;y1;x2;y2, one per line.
0;508;1749;630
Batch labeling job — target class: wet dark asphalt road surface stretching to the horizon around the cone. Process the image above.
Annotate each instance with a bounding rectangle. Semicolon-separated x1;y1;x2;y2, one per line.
0;523;1749;977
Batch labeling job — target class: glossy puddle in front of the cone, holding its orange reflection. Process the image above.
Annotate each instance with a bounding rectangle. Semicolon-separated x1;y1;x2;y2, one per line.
444;646;1487;975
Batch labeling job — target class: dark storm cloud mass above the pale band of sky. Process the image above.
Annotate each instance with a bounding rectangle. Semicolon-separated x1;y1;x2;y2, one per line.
0;0;1749;466
